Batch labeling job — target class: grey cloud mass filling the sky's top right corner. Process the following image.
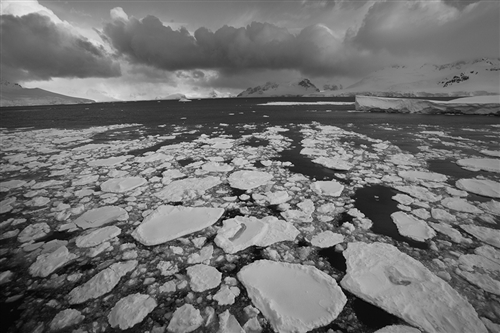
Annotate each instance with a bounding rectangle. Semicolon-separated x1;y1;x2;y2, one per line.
348;1;500;60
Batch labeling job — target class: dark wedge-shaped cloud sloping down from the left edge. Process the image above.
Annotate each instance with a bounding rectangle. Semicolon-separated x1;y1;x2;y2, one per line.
0;14;120;81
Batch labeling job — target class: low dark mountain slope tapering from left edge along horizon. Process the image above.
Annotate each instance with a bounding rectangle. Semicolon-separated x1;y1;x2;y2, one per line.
0;82;95;106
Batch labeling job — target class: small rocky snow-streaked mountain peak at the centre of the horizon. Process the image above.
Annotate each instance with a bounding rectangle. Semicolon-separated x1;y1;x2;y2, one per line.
237;79;319;97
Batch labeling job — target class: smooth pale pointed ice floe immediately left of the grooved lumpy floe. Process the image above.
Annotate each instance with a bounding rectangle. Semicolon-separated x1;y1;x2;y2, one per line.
132;205;224;245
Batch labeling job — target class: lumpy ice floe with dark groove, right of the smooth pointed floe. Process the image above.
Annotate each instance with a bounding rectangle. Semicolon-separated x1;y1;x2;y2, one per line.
214;216;300;254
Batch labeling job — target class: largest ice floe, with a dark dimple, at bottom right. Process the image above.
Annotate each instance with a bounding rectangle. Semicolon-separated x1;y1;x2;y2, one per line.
341;242;488;333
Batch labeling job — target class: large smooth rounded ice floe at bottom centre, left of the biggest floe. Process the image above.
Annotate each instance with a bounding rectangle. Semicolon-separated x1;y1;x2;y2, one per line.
238;260;347;333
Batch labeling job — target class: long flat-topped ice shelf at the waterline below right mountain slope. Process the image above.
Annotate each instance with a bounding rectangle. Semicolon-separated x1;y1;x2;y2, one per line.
355;96;500;114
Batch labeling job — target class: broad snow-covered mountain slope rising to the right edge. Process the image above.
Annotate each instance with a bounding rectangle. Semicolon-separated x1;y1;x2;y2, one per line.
314;58;500;96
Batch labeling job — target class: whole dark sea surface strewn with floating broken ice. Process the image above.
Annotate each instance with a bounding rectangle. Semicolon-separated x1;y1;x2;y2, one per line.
0;100;500;333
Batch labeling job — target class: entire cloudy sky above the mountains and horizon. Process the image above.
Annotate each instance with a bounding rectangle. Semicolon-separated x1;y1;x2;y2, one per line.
0;0;500;101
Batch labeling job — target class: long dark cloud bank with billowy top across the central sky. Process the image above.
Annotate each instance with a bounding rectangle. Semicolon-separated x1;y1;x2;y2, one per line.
102;16;370;75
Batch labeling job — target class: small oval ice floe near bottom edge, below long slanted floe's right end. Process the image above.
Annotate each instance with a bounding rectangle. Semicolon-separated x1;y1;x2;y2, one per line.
108;294;158;330
